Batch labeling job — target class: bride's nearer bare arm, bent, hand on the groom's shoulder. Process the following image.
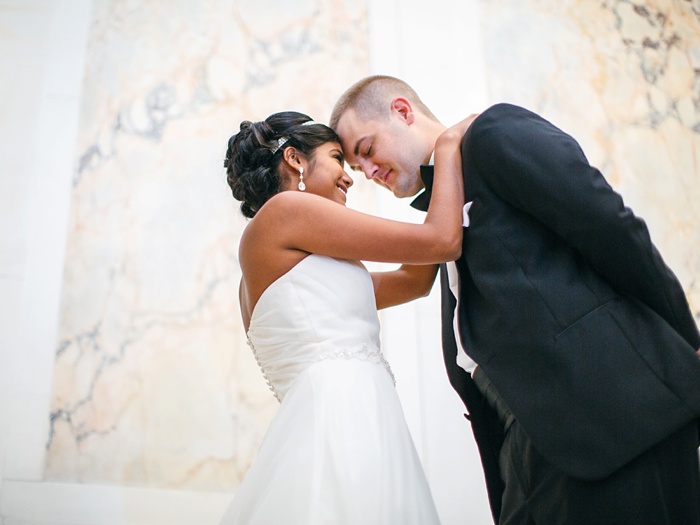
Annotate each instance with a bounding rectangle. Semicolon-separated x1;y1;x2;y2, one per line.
256;116;475;264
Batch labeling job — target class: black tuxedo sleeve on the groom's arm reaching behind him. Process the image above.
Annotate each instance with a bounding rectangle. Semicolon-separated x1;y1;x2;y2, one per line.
464;104;700;349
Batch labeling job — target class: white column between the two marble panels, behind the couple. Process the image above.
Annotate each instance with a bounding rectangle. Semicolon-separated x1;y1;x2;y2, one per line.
360;0;492;525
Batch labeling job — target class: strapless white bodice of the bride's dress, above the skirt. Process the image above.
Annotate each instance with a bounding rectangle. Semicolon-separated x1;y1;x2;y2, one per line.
248;255;393;401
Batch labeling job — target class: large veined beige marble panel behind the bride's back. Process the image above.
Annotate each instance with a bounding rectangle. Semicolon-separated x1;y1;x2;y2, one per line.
46;0;368;490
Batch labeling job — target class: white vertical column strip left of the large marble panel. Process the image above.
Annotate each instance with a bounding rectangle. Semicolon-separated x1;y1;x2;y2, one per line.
4;0;90;480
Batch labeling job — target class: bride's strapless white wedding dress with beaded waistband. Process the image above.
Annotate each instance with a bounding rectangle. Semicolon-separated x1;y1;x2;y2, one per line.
221;255;439;525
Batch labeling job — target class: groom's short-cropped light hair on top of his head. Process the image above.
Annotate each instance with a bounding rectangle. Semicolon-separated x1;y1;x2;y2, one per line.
329;75;437;129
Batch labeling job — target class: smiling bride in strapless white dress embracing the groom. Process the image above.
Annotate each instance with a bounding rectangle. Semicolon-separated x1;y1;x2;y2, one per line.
216;112;473;525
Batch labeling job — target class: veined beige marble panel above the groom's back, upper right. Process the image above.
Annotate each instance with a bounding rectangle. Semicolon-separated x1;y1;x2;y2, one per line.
482;0;700;323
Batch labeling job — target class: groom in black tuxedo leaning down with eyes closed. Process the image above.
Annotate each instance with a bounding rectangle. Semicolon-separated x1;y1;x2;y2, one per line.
330;76;700;525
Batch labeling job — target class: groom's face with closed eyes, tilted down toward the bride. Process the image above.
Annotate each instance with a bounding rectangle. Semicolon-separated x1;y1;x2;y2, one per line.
335;109;425;197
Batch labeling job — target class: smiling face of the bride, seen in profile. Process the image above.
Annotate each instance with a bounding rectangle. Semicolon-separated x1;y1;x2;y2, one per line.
304;142;353;205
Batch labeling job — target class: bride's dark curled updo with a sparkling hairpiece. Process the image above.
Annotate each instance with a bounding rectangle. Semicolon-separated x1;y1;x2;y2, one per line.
224;111;339;218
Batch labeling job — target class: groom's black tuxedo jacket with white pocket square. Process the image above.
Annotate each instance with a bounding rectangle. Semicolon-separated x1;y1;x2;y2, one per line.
421;104;700;514
